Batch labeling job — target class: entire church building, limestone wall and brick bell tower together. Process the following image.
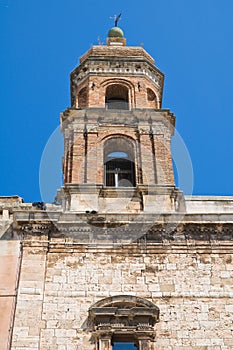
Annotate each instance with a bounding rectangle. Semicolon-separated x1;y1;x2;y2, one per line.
0;27;233;350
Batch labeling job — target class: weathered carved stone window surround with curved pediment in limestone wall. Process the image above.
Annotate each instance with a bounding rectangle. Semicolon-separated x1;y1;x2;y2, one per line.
89;295;159;349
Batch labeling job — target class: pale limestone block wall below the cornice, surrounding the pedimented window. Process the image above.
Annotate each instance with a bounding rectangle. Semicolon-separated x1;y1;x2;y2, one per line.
12;242;233;350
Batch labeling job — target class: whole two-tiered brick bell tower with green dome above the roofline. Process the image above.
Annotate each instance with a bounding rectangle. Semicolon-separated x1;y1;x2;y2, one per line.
59;26;183;213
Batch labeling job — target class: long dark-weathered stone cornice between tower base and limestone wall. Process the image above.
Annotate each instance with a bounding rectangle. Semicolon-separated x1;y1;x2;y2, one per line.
14;214;233;254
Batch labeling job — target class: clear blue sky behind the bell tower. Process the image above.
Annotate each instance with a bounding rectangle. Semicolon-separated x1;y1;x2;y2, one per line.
0;0;233;201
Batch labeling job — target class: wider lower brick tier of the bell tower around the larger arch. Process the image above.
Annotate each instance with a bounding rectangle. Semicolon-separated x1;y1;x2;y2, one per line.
63;110;174;189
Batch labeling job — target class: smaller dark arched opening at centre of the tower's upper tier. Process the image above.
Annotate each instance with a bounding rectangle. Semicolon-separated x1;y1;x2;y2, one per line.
105;84;129;109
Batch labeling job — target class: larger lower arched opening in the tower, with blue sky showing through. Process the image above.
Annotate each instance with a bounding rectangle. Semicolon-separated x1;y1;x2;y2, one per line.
104;137;136;187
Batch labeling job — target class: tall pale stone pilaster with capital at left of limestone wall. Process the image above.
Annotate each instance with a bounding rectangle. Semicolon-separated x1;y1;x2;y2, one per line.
11;224;48;350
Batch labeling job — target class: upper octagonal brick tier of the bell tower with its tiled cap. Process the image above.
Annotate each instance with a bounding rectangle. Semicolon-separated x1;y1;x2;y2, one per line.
71;45;164;109
